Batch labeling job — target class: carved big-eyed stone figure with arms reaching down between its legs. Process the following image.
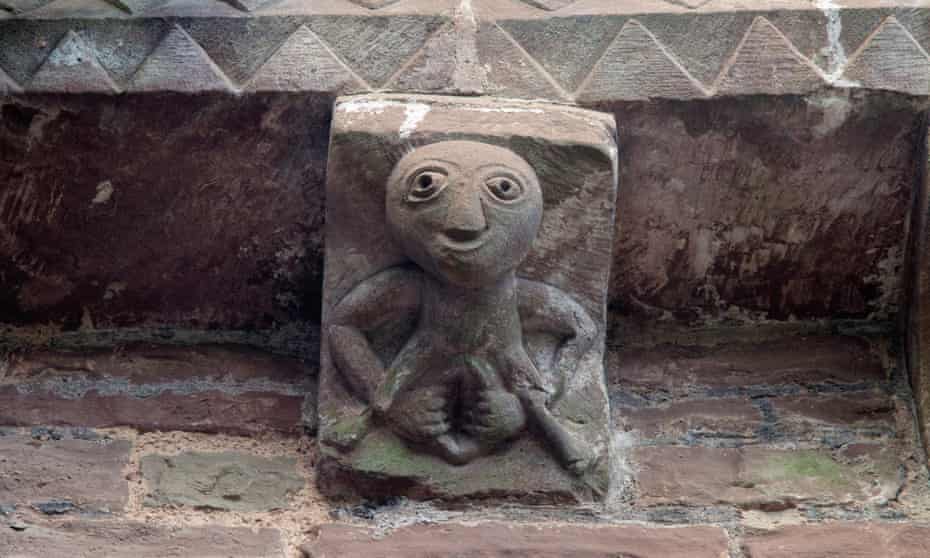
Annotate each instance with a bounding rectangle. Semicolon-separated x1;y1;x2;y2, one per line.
329;141;596;474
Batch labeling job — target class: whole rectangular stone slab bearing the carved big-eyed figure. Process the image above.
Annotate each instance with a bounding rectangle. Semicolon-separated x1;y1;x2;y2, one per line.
320;97;615;499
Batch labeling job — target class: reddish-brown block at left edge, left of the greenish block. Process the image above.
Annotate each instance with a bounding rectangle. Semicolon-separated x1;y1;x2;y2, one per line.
0;434;130;516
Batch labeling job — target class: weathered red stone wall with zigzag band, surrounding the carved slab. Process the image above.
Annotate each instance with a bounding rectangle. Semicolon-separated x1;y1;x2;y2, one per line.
0;0;930;558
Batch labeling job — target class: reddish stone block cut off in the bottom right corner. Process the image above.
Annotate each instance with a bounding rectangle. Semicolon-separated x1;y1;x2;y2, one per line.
743;522;930;558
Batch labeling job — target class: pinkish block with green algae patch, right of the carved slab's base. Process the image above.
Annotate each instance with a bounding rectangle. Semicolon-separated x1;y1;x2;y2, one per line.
633;446;903;510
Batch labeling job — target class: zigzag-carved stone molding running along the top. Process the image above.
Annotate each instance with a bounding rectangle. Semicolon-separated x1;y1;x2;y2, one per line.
0;0;930;99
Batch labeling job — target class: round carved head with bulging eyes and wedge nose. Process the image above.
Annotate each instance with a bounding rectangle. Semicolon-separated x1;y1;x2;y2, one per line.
386;141;543;287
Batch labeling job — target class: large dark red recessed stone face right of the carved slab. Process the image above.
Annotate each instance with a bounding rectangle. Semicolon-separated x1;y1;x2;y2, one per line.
599;95;922;325
